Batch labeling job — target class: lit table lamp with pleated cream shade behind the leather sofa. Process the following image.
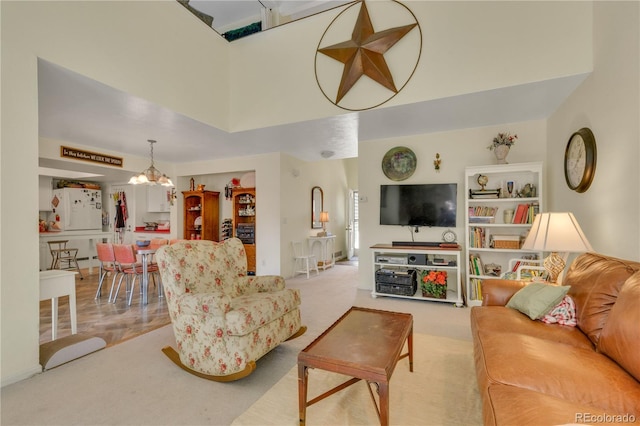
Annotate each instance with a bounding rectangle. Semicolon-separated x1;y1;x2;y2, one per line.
522;212;593;283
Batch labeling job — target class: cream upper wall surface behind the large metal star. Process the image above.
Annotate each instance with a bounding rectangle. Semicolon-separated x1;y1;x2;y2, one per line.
230;1;592;131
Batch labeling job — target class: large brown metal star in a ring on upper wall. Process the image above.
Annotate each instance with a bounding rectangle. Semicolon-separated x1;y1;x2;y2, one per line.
316;1;422;110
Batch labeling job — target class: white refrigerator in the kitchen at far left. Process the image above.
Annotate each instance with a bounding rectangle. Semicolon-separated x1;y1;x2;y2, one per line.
49;188;102;231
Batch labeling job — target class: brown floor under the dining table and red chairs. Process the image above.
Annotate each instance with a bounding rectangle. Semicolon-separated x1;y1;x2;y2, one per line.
40;268;171;346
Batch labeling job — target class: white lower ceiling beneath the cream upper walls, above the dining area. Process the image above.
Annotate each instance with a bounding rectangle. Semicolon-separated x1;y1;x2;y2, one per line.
38;1;585;181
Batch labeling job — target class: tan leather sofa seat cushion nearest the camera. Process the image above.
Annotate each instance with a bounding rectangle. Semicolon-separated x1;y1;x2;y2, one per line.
474;332;640;418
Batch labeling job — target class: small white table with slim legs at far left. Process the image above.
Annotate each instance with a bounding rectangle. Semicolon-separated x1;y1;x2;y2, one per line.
40;269;78;340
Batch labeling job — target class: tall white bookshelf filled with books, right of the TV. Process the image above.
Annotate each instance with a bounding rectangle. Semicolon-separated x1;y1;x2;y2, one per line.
465;162;544;306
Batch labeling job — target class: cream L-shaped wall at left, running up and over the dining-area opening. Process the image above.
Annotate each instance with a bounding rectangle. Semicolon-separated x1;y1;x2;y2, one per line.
0;1;229;385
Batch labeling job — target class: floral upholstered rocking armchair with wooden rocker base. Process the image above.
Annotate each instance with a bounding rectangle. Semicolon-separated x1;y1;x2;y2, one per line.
156;238;306;381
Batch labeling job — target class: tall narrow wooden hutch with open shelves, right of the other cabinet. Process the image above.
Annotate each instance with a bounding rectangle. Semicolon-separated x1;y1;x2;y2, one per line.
232;188;256;274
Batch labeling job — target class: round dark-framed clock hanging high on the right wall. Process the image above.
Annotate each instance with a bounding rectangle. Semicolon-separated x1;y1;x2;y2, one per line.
564;127;597;192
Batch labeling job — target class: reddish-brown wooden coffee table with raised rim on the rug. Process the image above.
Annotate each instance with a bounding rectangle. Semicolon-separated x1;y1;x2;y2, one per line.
298;307;413;425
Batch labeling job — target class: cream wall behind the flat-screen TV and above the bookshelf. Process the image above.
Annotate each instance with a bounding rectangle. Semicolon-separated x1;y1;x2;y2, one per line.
358;120;546;289
